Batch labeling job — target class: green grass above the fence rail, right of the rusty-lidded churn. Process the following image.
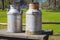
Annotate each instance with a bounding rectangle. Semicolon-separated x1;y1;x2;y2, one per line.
42;10;60;22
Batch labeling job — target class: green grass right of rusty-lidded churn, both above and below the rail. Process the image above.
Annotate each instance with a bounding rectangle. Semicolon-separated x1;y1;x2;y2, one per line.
42;10;60;33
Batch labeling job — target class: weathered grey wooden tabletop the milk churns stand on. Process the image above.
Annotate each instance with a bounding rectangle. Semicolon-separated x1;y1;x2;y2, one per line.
0;31;48;40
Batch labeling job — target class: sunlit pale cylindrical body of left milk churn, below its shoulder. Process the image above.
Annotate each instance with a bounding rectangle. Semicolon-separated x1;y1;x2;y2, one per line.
7;15;17;32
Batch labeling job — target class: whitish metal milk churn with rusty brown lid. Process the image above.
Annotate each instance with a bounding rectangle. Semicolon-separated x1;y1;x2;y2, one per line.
25;3;42;35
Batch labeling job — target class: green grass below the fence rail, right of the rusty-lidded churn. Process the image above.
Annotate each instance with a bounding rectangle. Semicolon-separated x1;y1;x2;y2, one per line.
42;24;60;34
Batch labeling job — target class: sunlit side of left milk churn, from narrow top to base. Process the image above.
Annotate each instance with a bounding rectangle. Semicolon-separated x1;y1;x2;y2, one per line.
7;5;21;32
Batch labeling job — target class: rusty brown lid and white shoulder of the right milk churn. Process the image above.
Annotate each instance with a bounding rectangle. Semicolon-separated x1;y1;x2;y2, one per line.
26;2;40;14
